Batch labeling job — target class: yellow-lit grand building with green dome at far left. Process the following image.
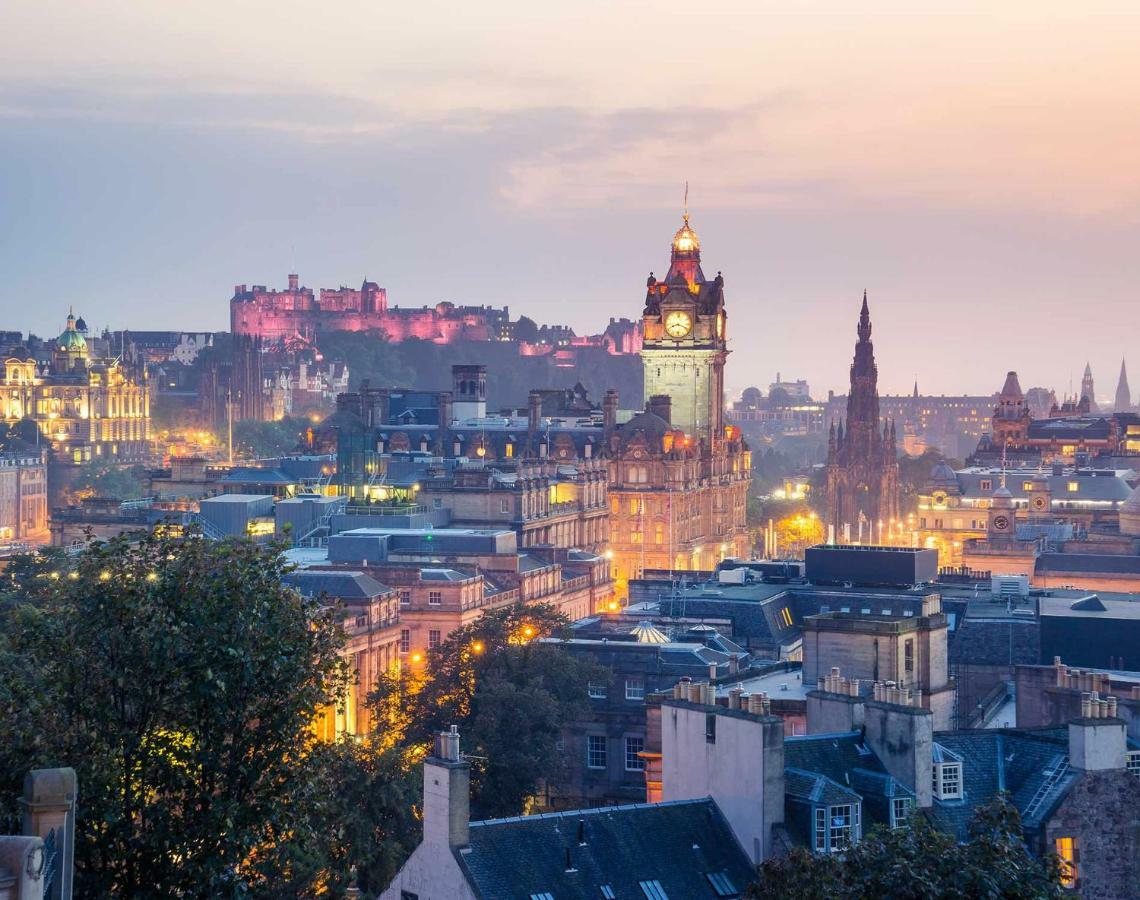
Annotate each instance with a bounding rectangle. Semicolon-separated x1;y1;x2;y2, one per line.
0;315;150;499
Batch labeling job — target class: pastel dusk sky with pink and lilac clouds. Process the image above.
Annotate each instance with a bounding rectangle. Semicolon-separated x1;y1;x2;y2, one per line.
0;0;1140;399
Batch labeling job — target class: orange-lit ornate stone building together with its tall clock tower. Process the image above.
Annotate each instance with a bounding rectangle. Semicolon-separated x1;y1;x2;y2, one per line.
603;214;751;592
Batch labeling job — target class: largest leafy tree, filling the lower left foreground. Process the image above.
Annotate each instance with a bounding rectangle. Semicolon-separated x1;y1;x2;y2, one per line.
0;535;347;898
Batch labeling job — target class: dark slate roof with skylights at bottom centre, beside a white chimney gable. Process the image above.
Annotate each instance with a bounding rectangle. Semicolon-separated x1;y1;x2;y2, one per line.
456;798;754;900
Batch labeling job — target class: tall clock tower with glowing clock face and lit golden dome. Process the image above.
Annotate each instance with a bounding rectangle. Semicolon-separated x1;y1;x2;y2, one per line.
641;212;728;446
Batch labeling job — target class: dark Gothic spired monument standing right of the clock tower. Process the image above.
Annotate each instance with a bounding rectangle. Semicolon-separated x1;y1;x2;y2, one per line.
827;291;898;543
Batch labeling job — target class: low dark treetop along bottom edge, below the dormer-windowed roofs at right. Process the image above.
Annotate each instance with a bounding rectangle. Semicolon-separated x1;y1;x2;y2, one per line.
746;796;1062;900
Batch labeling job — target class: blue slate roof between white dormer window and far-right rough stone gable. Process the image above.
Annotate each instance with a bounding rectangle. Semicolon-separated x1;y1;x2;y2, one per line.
930;728;1077;840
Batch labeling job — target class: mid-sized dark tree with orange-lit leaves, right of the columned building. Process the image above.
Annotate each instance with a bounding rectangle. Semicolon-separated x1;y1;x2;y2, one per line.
373;603;604;818
